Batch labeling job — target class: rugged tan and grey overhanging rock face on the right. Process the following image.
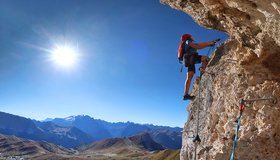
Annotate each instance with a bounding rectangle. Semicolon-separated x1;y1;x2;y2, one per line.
161;0;280;160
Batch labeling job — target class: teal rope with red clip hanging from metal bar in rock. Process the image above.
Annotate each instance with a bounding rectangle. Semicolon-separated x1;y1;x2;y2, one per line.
230;97;277;160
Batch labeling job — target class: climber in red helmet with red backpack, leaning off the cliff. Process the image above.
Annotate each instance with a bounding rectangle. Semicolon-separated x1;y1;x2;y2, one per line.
178;34;219;100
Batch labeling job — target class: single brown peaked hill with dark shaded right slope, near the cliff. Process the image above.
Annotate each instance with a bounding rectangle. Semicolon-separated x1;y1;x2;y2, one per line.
78;133;164;160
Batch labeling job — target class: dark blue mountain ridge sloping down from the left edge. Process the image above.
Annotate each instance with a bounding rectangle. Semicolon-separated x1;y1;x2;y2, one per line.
0;112;94;148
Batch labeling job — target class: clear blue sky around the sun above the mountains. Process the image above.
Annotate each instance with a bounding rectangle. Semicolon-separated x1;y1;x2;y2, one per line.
0;0;227;127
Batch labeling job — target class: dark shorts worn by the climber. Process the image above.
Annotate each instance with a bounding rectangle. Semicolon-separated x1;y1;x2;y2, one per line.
183;53;202;73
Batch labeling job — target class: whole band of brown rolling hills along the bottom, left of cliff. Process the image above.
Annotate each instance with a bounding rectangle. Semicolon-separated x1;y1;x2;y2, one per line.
0;133;180;160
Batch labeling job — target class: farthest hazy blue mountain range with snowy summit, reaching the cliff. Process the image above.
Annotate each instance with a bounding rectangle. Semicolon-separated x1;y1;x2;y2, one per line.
48;115;182;149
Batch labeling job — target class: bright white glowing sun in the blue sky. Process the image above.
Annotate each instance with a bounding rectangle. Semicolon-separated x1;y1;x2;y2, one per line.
51;45;78;68
